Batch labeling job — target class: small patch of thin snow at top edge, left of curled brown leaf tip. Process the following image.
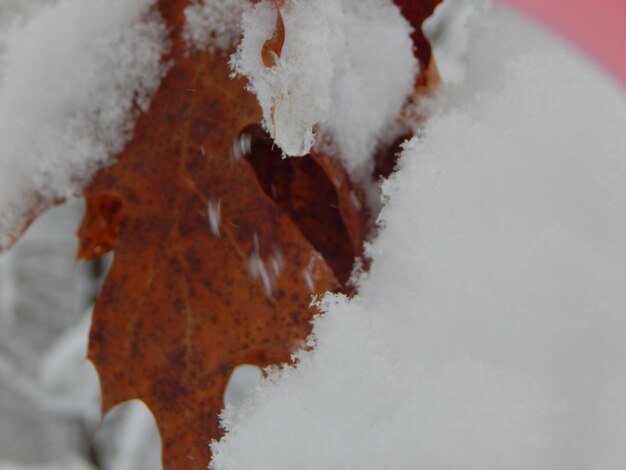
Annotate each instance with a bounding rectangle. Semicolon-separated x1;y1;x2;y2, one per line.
184;0;250;51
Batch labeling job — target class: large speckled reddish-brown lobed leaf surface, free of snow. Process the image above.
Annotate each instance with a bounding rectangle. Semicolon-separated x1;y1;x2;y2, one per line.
81;2;354;469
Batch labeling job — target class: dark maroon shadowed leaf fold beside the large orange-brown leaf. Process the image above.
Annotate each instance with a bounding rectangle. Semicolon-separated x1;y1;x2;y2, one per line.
239;125;369;285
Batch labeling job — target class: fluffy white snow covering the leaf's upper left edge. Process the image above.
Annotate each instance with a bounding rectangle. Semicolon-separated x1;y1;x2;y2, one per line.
0;0;166;250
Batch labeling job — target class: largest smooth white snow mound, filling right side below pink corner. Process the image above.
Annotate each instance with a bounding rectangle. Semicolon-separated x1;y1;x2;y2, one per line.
212;2;626;470
